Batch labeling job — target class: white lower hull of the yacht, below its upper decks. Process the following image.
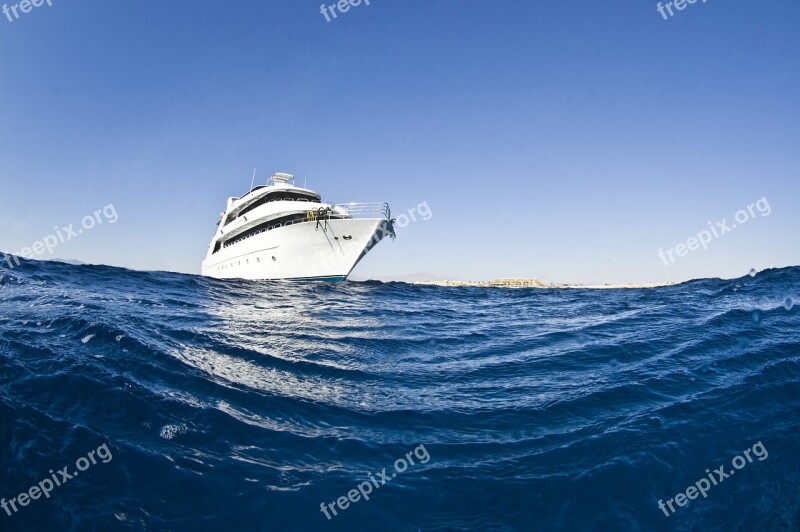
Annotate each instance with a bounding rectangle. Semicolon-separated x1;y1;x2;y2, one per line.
202;218;393;281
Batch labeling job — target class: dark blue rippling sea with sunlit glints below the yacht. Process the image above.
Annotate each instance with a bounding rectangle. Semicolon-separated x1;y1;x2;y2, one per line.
0;261;800;531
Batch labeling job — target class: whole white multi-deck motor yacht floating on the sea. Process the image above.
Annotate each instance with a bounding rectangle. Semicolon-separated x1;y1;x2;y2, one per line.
202;173;395;281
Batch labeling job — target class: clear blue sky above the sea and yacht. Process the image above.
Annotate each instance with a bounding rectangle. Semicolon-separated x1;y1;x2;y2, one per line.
0;0;800;282
